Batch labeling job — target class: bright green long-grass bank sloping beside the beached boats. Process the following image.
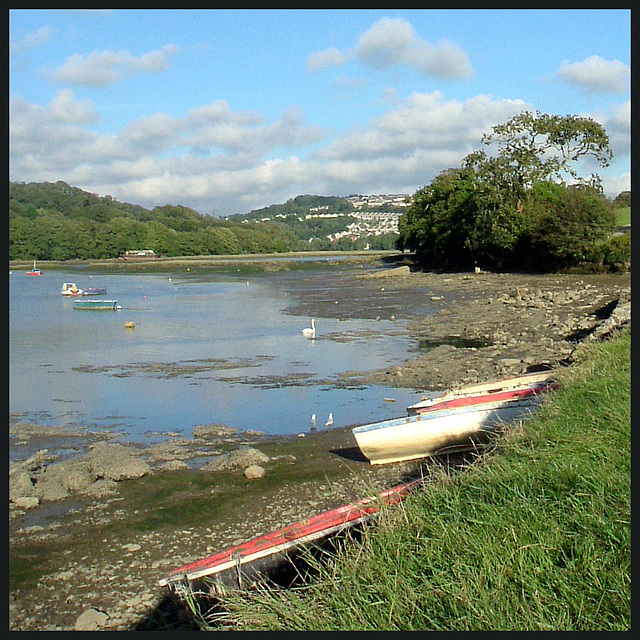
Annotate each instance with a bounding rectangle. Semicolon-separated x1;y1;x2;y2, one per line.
208;329;631;630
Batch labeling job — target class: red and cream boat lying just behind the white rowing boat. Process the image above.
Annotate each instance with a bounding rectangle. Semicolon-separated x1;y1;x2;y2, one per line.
407;371;556;414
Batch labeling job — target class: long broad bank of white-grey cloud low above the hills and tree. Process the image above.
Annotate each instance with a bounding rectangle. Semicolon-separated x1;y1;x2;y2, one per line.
9;90;630;215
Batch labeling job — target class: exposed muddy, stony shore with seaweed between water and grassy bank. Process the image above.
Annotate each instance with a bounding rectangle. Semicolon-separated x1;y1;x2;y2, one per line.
9;267;631;630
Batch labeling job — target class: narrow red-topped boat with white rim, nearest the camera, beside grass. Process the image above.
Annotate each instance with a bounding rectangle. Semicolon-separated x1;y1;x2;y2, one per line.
159;480;422;590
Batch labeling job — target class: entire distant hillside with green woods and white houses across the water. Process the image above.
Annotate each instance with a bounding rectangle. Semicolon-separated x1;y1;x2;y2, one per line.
9;181;402;260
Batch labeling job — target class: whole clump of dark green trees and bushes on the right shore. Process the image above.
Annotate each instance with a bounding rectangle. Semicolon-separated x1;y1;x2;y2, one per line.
398;112;631;271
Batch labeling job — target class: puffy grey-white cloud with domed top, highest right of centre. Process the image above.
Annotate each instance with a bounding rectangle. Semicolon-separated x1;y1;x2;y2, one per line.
307;18;473;79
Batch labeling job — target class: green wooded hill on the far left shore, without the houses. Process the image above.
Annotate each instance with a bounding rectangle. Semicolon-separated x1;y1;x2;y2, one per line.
9;181;350;260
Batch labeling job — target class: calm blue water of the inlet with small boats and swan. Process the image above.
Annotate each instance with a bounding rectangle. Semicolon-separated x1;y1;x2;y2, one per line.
9;264;420;450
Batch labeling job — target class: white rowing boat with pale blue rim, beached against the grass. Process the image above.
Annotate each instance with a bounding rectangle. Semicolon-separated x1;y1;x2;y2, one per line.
352;393;542;464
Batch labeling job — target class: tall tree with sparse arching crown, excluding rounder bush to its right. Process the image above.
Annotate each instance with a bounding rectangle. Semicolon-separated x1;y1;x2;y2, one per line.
398;112;612;267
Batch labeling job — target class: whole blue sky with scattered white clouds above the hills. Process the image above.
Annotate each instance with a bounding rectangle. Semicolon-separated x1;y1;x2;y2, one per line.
9;9;631;216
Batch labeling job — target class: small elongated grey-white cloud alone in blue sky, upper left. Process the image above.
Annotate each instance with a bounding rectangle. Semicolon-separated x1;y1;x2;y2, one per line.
49;45;179;87
